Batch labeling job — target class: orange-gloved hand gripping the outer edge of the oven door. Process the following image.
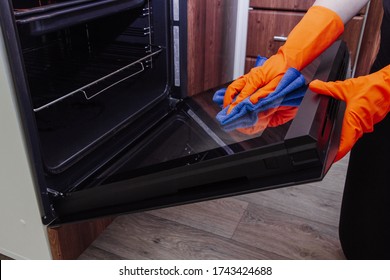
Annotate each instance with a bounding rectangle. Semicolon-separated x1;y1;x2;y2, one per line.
309;65;390;161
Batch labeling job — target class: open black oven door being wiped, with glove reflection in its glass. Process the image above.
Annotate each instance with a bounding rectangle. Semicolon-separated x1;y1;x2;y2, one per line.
53;42;348;223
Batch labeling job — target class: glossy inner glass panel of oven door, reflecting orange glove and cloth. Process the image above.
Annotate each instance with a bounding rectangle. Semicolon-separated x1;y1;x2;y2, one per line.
105;82;306;183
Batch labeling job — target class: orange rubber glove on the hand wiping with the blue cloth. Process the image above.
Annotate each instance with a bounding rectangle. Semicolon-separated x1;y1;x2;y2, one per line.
223;6;344;113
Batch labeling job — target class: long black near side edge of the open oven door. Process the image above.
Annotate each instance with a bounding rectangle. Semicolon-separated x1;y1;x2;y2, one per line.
54;140;323;223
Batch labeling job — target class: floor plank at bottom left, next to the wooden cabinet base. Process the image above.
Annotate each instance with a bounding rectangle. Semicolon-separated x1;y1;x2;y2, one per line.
80;213;283;259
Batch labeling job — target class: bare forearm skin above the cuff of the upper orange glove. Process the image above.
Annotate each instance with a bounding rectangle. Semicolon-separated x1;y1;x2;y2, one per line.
313;0;369;24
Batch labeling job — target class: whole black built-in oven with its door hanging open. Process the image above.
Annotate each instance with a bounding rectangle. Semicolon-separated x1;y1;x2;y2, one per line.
0;0;349;228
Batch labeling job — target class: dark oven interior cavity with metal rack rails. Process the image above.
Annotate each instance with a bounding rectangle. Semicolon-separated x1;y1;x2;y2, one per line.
12;0;175;182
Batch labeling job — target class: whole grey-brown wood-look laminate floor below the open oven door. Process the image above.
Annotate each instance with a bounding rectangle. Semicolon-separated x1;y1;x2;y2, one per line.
79;157;348;260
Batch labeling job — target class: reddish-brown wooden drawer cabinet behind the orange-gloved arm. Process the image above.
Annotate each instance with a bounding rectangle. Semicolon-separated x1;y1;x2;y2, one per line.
245;0;366;75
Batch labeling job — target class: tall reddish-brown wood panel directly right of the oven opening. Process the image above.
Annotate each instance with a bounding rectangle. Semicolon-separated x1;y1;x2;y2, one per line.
187;0;237;96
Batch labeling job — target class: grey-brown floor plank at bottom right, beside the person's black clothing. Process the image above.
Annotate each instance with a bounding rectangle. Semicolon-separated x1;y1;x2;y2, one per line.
233;204;344;259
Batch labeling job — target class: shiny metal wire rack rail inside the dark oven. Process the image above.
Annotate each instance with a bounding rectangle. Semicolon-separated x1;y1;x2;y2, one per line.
33;47;162;113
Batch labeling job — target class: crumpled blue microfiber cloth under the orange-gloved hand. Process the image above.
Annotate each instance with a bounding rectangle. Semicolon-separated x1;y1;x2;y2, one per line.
213;56;307;126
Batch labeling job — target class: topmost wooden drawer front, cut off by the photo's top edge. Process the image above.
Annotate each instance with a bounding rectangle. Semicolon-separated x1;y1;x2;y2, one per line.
250;0;315;11
